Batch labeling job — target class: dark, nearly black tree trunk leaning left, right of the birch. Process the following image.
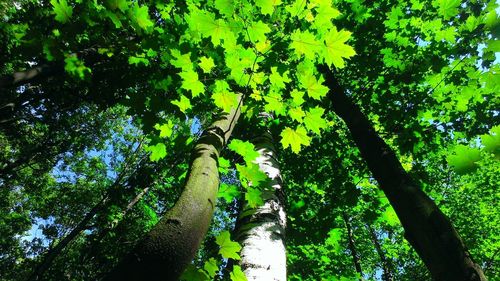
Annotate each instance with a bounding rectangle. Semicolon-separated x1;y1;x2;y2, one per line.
323;69;486;281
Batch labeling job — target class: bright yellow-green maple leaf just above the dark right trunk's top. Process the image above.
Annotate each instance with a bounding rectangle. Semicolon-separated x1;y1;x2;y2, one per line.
323;27;356;68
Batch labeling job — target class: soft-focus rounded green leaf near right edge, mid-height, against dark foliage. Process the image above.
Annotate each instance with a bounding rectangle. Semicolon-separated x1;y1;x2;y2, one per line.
446;145;481;174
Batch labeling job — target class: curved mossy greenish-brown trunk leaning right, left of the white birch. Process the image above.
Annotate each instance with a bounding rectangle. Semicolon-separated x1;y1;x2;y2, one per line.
104;97;241;281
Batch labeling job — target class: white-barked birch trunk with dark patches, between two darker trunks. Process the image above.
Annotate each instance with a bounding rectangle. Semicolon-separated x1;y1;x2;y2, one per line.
236;129;286;281
